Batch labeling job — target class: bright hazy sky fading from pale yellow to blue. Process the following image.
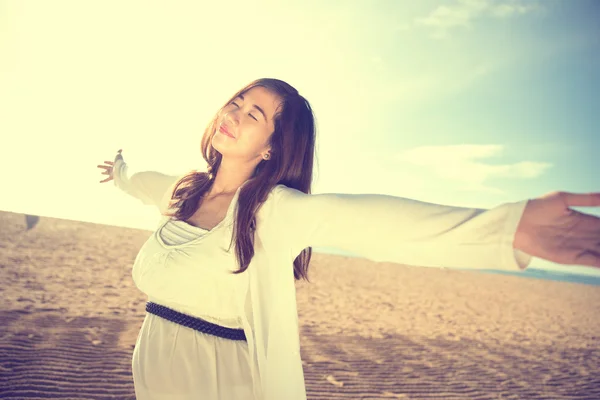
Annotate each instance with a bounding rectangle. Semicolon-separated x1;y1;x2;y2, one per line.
0;0;600;273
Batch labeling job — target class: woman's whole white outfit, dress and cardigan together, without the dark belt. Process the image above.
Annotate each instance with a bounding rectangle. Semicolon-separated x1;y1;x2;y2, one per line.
114;160;531;400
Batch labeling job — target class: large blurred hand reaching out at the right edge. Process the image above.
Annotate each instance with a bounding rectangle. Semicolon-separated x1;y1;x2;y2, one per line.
513;192;600;268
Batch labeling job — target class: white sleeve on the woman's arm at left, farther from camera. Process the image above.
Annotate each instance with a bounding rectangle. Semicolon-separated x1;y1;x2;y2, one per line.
113;159;179;211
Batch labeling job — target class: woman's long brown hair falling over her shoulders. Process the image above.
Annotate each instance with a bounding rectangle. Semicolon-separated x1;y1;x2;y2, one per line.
164;78;316;282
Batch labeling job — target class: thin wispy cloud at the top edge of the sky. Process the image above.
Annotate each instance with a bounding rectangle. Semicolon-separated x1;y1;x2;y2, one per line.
414;0;540;39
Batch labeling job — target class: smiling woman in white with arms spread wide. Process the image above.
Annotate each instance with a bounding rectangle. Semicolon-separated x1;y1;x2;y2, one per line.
98;79;600;400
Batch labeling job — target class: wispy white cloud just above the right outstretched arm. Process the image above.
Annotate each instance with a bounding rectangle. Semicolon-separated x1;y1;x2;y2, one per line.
398;144;552;193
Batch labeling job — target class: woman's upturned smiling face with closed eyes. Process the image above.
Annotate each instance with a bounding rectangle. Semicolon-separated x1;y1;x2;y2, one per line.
212;86;281;163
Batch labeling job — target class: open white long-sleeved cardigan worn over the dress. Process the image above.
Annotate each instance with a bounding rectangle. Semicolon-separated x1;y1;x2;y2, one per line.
113;160;532;400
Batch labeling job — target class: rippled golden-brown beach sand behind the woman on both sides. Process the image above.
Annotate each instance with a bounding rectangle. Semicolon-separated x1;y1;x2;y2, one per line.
0;212;600;400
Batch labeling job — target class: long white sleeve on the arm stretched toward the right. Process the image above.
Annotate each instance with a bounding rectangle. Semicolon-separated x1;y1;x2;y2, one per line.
269;185;532;270
